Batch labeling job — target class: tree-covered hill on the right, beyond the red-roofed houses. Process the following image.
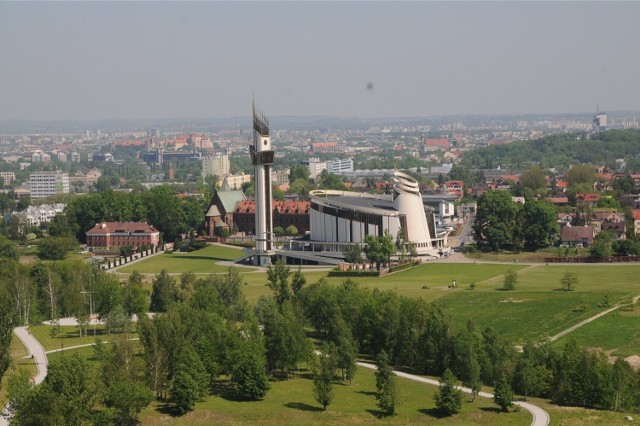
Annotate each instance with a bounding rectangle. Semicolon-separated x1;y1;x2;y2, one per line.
462;129;640;172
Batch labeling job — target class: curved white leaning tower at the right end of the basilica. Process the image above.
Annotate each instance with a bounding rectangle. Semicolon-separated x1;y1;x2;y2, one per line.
393;172;432;251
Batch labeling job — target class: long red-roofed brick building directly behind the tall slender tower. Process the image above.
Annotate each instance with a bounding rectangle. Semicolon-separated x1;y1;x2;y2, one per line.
233;200;310;234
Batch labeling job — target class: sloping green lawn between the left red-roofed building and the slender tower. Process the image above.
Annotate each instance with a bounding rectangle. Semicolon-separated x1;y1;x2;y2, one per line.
117;245;255;274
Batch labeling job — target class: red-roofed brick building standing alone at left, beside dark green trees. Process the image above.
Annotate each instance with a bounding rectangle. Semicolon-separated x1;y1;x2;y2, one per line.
86;222;160;249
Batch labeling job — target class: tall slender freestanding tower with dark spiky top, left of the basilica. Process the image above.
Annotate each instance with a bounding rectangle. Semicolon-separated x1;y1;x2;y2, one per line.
249;102;274;266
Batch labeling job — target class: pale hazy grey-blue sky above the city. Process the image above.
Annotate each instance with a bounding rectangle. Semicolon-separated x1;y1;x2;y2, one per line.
0;2;640;120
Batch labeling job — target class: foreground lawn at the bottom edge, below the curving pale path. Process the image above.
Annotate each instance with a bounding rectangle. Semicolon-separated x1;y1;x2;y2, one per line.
140;368;531;425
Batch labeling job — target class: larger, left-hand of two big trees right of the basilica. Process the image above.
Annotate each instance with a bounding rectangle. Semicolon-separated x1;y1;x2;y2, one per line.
473;190;522;251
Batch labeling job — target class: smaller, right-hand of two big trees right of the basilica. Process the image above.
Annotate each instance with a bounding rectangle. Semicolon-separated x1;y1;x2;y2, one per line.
522;200;559;249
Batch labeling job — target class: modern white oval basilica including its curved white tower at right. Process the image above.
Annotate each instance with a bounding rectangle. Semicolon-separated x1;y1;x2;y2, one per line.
310;172;439;256
